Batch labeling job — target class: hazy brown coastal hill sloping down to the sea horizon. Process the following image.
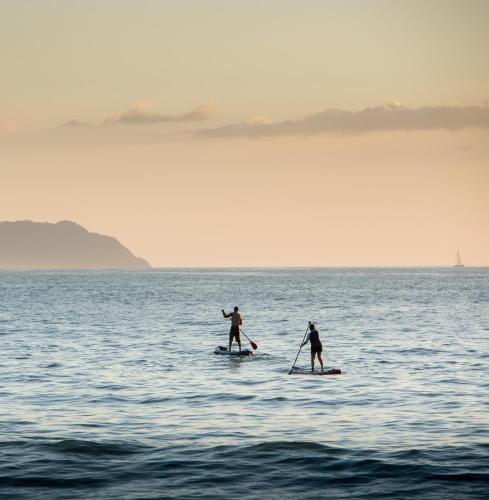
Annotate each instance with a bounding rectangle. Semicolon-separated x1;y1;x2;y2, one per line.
0;220;151;269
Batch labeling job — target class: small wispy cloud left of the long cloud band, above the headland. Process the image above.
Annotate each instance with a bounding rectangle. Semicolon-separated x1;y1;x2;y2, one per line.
102;103;214;125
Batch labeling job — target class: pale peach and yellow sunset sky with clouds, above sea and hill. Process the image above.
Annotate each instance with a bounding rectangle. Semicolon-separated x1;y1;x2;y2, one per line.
0;0;489;267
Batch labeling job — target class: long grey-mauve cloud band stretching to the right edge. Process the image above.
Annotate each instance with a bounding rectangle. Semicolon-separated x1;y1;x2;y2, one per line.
194;101;489;137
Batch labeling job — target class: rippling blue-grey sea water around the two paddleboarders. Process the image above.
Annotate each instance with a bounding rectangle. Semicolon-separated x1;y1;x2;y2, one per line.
0;268;489;499
